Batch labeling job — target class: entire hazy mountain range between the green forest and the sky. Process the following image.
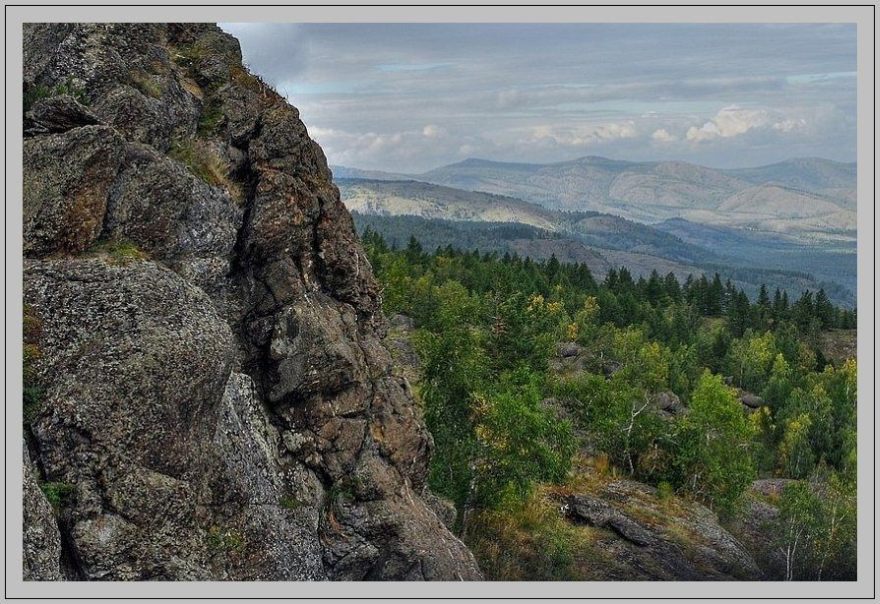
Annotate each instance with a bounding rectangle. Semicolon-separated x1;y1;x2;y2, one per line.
334;157;856;305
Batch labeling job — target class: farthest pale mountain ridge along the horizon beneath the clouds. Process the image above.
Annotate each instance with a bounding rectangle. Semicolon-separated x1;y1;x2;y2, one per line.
333;156;856;241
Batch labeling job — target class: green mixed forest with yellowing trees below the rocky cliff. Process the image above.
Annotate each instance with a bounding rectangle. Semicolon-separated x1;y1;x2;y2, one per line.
362;228;857;580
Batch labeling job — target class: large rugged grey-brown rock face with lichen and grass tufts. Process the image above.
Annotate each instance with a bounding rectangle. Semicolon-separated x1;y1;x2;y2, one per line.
24;24;481;580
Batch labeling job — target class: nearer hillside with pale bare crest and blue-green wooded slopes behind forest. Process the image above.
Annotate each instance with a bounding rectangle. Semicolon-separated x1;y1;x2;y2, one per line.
337;179;855;306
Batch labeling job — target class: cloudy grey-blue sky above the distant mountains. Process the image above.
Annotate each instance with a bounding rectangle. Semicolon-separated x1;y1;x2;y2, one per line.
222;23;856;172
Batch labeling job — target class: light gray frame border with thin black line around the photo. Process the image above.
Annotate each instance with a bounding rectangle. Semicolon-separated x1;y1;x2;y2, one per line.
4;4;876;599
